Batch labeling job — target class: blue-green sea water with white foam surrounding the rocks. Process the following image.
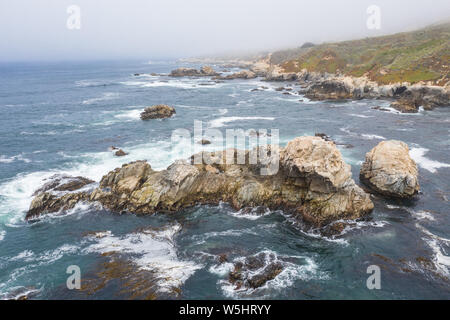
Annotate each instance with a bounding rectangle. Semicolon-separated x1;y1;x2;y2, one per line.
0;62;450;299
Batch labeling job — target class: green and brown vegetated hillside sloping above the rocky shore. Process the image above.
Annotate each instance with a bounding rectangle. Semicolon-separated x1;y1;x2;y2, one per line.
271;23;450;85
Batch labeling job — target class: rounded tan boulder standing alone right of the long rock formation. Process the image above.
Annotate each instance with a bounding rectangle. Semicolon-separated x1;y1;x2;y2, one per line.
360;140;419;198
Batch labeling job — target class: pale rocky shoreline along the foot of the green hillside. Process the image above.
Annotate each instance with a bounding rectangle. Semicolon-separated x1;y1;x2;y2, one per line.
169;59;450;113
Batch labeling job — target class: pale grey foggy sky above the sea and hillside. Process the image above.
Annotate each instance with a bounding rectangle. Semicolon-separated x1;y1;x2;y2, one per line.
0;0;450;61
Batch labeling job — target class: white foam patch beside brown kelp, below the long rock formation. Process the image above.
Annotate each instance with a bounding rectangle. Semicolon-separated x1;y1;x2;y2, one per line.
83;224;202;292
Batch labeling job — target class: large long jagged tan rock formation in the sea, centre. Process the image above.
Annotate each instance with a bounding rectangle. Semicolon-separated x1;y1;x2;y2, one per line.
26;137;373;226
